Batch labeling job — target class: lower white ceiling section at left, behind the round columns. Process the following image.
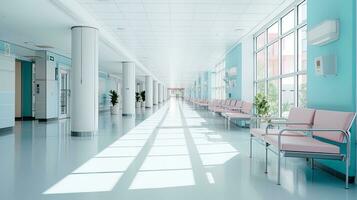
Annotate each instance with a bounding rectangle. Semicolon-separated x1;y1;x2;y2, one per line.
0;0;145;76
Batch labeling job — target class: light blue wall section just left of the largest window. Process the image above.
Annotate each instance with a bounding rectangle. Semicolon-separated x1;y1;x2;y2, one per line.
225;44;242;99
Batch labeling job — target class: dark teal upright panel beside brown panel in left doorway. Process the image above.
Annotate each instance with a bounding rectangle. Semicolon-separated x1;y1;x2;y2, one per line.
21;61;32;117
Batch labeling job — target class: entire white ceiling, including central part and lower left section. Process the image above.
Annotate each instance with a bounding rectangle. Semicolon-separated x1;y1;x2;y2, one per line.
0;0;286;87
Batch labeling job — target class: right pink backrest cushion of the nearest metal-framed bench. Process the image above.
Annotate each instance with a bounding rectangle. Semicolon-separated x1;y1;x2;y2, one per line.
313;110;355;143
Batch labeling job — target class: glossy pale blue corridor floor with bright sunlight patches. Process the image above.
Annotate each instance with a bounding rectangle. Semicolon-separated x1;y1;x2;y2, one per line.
0;100;357;200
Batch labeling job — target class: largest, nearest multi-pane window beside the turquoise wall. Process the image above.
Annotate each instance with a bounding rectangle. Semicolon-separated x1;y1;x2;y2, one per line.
254;1;307;117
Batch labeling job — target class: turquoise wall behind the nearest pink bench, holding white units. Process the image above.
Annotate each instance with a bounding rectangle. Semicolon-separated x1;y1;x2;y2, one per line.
307;0;356;175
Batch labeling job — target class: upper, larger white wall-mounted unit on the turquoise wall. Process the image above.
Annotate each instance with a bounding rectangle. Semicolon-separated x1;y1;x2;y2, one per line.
307;19;339;46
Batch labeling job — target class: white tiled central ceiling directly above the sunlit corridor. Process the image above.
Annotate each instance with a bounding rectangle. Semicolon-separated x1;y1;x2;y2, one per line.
77;0;284;87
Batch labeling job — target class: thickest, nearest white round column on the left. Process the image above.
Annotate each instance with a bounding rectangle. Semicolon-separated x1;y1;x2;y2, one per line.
71;26;98;136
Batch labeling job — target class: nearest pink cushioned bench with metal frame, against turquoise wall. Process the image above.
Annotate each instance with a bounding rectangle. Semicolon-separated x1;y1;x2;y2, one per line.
250;108;356;189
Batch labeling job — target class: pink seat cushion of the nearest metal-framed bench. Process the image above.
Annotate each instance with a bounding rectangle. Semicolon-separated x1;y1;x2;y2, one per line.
264;135;340;154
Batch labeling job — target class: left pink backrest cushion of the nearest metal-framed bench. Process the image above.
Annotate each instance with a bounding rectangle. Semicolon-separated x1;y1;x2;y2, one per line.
287;107;315;128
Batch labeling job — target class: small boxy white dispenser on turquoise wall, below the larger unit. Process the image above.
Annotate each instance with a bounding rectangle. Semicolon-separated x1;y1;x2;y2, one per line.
314;55;337;76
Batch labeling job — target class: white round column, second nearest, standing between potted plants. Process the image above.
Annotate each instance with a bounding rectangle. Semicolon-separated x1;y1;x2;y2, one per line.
123;62;136;115
